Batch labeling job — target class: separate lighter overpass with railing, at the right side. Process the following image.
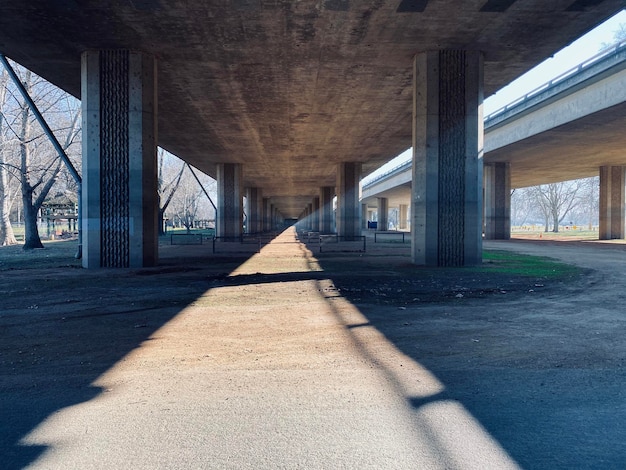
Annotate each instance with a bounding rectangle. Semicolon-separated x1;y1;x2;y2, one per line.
362;38;626;238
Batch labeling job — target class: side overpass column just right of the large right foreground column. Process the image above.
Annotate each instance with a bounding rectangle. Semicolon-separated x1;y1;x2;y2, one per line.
483;162;511;240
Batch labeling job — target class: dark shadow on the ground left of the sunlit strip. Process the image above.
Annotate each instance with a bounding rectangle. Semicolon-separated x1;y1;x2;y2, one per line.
0;242;260;470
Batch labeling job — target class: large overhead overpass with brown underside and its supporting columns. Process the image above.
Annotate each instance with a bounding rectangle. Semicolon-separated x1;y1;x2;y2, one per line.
0;0;624;268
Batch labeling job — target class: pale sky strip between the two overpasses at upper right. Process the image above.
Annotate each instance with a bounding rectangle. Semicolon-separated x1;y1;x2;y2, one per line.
363;10;626;181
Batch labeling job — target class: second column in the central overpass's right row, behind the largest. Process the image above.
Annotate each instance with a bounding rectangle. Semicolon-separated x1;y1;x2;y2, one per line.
337;162;361;237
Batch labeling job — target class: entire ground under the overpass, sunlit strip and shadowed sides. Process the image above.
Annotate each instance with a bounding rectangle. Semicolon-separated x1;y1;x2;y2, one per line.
0;227;626;470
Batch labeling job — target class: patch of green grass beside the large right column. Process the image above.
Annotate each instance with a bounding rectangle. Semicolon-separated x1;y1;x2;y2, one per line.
478;251;582;279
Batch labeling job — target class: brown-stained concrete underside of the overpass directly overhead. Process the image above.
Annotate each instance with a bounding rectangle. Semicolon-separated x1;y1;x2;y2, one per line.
0;0;624;217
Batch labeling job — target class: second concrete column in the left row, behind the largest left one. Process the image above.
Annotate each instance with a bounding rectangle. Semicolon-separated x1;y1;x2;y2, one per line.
216;163;243;237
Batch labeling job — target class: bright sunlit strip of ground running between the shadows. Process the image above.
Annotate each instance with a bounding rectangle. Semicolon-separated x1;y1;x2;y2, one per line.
22;229;517;469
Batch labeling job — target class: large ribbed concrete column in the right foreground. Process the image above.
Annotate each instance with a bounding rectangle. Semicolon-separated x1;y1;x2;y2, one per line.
411;50;483;266
